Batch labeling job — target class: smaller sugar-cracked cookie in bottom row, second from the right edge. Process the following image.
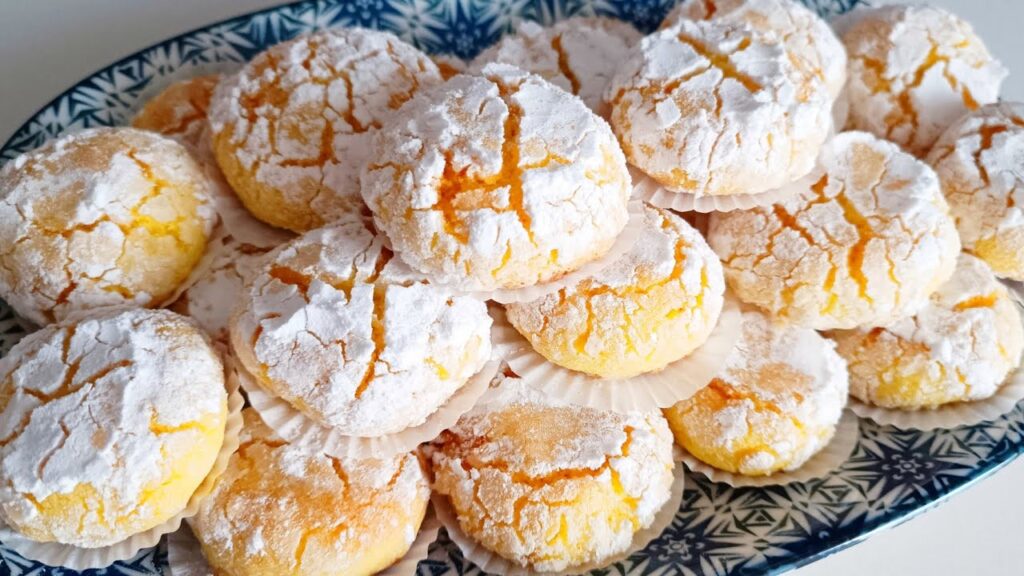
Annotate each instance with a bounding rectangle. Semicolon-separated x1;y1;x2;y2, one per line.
666;312;848;476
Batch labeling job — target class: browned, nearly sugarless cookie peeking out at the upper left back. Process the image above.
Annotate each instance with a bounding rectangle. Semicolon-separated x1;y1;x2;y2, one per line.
131;74;220;150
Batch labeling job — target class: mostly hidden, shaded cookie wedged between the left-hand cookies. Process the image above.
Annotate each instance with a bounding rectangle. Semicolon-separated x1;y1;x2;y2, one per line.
170;230;286;344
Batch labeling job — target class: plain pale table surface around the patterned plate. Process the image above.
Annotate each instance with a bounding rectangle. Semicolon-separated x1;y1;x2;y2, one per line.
0;0;1024;576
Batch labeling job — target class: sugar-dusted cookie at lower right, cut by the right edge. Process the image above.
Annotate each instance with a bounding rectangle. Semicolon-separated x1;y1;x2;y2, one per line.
831;254;1024;409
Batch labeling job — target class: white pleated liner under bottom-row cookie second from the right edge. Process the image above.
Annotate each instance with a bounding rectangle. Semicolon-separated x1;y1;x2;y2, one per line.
677;410;860;488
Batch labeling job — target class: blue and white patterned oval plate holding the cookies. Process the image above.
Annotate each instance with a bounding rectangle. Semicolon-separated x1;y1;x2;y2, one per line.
8;0;1024;576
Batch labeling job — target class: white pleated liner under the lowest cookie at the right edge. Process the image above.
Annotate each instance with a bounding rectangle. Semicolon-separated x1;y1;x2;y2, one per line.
849;368;1024;430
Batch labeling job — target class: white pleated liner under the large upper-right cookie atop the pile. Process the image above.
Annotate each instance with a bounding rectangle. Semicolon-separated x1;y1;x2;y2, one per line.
630;167;796;212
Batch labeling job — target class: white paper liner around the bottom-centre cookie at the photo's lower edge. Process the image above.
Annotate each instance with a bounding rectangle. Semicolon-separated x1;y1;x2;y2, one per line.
430;464;686;576
